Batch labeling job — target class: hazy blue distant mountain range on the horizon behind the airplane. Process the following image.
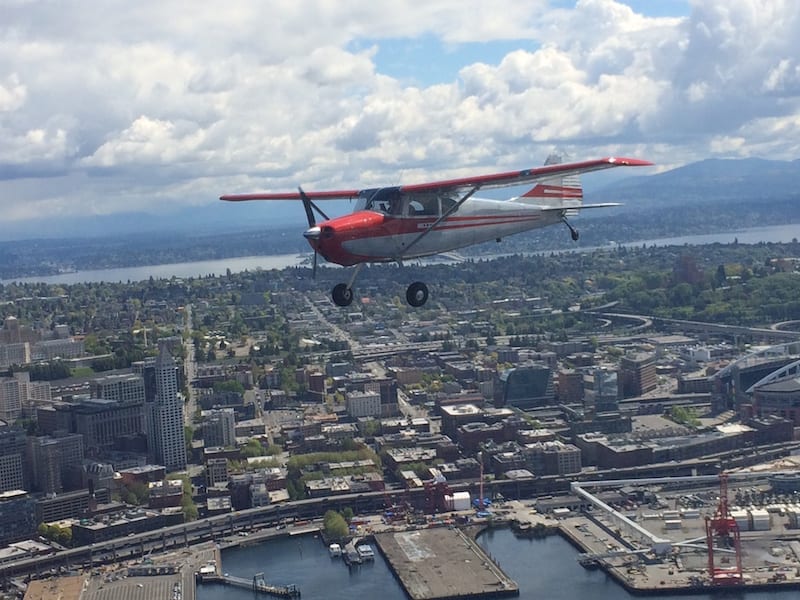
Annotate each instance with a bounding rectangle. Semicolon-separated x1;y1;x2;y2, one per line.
0;158;800;240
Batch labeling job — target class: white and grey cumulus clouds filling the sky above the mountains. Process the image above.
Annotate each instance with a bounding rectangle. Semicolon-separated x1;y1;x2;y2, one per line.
0;0;800;225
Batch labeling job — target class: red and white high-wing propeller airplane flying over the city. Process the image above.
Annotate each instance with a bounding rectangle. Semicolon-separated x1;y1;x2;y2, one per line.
220;156;653;306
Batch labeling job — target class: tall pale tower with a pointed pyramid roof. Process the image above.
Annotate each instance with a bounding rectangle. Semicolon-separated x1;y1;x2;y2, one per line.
148;345;186;469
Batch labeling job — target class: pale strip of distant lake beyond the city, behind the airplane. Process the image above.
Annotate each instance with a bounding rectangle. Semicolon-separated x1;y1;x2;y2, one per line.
0;223;800;284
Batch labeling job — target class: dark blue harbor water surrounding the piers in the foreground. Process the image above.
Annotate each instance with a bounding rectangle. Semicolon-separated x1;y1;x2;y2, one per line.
197;529;798;600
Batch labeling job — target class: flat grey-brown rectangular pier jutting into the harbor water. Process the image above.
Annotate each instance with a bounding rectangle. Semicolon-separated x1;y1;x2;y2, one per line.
375;527;519;600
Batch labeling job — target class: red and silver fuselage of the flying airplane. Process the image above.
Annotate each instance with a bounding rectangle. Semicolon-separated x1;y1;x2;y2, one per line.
309;198;562;266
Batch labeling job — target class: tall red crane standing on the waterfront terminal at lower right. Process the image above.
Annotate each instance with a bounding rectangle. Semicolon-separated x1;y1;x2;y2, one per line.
706;473;744;585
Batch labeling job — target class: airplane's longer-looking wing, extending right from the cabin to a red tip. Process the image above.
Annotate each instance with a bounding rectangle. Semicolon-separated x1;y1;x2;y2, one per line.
400;157;653;193
